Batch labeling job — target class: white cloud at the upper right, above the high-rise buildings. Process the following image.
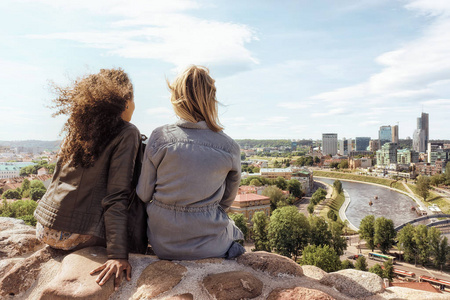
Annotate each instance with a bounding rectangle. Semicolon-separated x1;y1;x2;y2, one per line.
311;0;450;116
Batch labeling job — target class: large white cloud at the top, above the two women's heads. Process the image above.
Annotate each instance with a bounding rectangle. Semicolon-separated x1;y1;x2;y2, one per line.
28;0;258;69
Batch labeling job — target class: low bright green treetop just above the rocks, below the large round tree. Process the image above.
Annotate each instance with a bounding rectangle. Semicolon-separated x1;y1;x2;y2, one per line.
301;245;341;272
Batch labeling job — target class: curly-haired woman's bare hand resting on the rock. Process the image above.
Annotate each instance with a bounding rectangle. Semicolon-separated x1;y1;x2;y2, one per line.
90;259;131;291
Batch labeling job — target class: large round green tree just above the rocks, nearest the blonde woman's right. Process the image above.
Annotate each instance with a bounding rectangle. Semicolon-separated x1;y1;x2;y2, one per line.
269;206;309;260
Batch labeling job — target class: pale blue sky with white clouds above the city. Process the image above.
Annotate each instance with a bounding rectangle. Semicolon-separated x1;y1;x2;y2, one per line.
0;0;450;140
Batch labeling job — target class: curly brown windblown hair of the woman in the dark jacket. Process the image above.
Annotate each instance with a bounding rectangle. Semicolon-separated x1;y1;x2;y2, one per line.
52;68;133;168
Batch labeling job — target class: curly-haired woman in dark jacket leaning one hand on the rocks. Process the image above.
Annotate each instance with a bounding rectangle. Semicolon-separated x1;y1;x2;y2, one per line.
35;69;140;288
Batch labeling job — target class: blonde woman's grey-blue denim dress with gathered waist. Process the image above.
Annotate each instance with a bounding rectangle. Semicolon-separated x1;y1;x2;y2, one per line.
137;120;243;259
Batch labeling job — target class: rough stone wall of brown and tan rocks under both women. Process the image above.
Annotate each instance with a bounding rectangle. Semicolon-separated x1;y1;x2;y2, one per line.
0;218;448;300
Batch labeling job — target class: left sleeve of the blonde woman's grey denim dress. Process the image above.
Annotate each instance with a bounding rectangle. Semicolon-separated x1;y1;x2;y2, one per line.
136;142;156;203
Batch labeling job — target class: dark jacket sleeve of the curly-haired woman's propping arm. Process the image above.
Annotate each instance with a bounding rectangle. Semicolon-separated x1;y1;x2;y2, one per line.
102;126;140;259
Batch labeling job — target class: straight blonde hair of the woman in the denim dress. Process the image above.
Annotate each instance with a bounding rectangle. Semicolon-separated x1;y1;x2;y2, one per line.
167;65;223;132
